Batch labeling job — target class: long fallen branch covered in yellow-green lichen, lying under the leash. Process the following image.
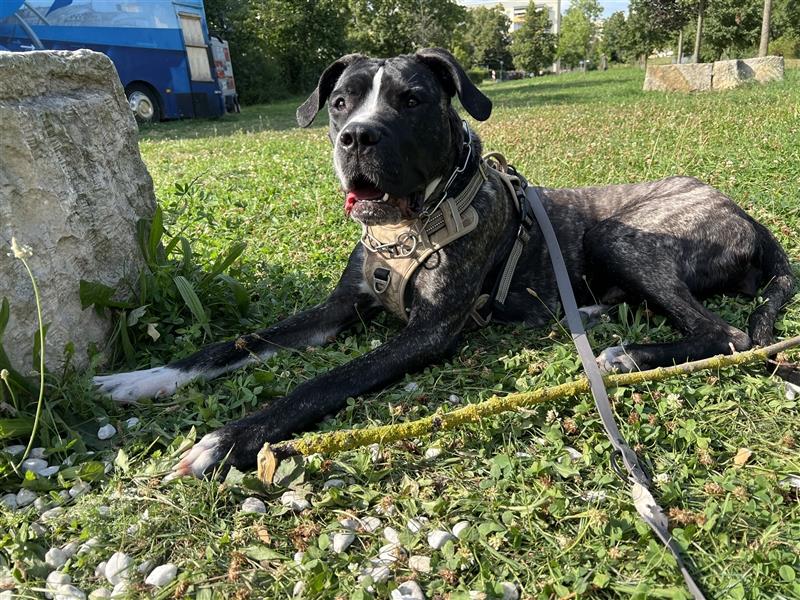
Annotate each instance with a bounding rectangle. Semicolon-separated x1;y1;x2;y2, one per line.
258;336;800;484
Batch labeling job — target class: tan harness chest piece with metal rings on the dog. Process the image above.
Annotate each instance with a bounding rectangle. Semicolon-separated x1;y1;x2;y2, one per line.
361;161;487;321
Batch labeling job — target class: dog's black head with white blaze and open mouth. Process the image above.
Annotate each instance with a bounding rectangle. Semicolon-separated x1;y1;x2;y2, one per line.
297;48;492;225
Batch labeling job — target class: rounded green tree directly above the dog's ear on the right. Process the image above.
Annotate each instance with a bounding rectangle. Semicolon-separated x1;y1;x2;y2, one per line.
459;6;512;69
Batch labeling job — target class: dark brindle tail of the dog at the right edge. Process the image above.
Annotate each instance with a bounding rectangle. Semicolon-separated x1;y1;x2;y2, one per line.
748;223;800;385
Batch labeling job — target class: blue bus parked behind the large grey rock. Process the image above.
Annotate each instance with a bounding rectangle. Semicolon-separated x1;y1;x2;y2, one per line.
0;0;239;122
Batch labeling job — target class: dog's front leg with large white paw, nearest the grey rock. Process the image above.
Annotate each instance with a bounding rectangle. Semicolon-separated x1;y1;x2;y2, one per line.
94;244;379;402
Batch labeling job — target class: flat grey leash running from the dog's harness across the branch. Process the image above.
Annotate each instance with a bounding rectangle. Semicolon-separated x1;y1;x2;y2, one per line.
525;185;705;600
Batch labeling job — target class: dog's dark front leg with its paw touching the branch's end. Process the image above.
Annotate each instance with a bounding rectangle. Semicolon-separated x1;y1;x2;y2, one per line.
171;315;464;477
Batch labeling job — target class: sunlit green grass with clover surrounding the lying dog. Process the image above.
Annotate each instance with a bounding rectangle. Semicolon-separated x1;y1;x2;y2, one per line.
0;69;800;599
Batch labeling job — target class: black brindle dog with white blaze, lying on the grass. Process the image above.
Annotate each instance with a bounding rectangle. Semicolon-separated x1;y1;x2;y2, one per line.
96;49;794;475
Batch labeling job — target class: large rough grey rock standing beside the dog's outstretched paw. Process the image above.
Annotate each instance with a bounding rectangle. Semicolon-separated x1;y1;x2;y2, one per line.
0;50;155;372
